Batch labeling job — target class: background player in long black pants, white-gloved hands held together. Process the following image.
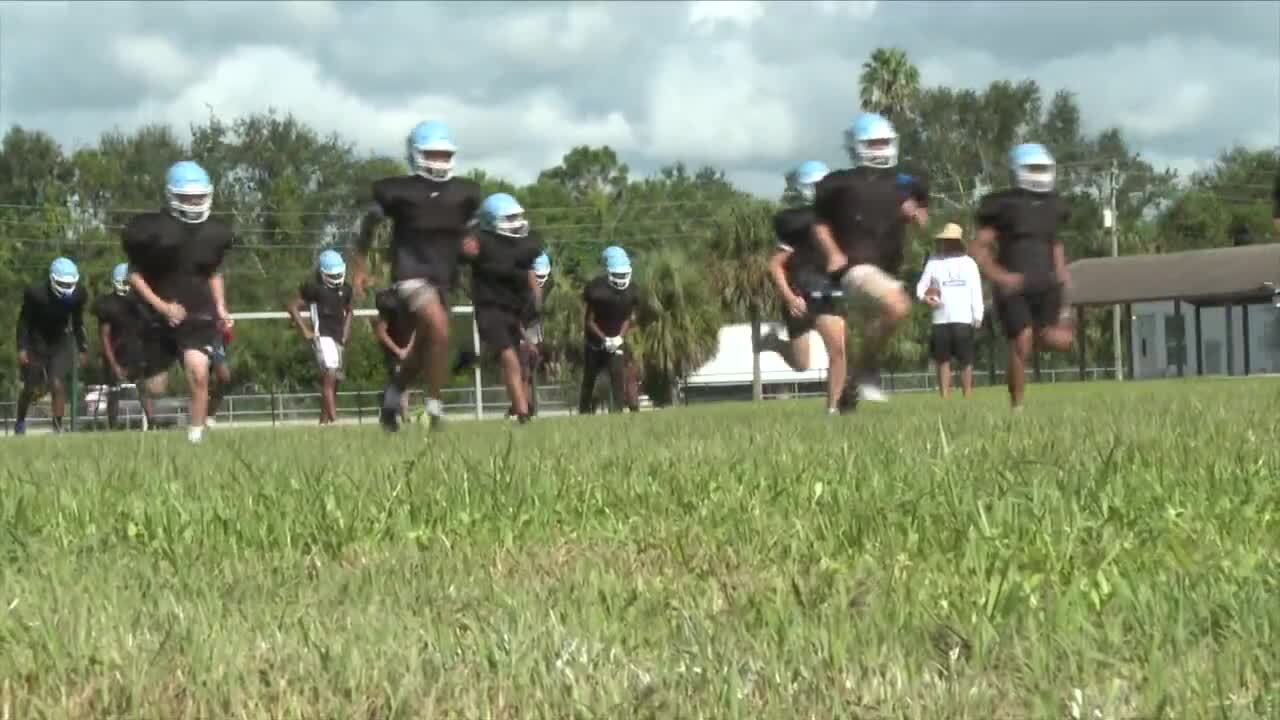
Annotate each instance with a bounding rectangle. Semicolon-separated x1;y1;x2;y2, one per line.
577;246;640;415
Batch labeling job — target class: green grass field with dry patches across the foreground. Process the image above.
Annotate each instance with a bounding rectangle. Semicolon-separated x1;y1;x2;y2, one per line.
0;380;1280;720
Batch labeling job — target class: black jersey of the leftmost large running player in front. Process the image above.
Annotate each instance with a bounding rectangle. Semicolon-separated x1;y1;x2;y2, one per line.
123;211;232;316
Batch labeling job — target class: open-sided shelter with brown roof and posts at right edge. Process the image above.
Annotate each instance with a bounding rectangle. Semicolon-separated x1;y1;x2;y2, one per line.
1069;243;1280;378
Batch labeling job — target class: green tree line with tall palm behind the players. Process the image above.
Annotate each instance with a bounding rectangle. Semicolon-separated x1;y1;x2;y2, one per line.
0;49;1276;402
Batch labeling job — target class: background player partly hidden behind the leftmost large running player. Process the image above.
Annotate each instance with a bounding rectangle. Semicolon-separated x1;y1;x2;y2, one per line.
93;263;156;430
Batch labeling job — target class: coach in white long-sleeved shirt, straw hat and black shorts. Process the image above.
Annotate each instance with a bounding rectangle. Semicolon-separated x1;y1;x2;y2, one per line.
915;223;983;398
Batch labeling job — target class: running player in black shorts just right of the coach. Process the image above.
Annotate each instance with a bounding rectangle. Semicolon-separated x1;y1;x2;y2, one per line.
969;142;1075;413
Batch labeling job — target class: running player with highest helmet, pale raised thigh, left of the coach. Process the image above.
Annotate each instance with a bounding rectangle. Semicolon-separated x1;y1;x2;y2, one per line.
814;113;928;411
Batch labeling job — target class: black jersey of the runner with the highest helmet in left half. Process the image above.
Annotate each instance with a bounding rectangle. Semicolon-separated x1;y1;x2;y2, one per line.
372;176;480;288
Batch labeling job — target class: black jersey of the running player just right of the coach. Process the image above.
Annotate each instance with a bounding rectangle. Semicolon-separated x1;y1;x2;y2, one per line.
978;188;1070;284
